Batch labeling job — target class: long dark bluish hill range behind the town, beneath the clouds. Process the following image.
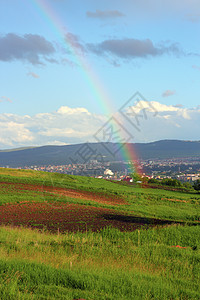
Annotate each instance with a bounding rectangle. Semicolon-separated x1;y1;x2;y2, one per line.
0;140;200;167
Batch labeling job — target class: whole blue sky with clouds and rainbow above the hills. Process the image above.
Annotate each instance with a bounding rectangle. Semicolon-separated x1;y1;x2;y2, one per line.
0;0;200;149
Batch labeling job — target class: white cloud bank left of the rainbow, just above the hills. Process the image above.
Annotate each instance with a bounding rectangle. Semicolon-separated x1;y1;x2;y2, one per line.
0;106;106;149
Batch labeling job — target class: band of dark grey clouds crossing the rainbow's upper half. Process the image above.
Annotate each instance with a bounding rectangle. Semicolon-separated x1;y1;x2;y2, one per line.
0;30;197;65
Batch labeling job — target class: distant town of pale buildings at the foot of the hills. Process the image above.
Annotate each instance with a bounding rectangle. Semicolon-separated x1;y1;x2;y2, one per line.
10;157;200;182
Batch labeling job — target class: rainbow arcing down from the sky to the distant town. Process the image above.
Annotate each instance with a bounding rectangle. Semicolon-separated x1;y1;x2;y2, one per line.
31;0;141;174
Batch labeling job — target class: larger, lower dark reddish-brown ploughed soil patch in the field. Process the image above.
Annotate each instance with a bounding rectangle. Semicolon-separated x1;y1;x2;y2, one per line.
0;203;174;233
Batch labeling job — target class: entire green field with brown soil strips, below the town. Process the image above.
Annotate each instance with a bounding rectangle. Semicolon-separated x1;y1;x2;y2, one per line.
0;169;200;300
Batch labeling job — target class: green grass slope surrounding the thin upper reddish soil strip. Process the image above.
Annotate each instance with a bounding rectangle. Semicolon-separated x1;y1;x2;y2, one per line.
0;168;200;222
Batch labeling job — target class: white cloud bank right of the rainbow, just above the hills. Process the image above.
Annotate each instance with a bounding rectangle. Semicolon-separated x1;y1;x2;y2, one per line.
118;101;200;142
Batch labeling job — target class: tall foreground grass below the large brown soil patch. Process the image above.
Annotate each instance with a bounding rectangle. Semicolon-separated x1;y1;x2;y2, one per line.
0;225;200;299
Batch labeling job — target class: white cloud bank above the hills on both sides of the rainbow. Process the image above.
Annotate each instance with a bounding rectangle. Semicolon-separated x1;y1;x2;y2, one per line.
0;101;200;149
